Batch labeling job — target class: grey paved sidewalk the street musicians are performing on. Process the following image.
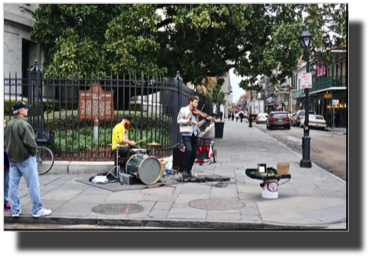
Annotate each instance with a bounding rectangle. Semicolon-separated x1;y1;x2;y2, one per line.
4;120;346;230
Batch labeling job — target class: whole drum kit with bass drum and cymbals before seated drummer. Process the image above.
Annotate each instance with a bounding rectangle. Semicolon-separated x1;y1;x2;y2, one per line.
108;140;163;185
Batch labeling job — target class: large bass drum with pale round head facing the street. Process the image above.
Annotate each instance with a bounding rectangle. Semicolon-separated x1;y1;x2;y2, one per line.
125;154;162;185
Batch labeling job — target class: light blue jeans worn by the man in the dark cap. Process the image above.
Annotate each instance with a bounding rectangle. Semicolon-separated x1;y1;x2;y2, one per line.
9;156;42;213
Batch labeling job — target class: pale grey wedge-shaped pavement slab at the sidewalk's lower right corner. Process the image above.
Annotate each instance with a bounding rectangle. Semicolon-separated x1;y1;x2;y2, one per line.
297;206;346;223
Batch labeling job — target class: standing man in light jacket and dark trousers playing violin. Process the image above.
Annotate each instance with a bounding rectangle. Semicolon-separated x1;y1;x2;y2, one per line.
177;96;212;181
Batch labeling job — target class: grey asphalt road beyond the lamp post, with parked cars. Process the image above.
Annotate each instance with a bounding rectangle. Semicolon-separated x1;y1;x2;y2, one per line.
251;122;347;181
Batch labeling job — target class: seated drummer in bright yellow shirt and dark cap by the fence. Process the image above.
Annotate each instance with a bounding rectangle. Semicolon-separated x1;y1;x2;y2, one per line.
111;114;136;157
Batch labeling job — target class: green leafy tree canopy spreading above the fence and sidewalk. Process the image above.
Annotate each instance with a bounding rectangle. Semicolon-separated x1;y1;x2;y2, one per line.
31;4;346;90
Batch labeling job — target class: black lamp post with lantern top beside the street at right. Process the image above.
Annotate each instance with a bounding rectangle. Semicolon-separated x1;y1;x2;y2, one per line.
299;24;313;168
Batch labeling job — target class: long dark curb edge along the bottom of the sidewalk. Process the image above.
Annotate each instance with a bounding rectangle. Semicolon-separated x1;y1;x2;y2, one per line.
4;216;334;230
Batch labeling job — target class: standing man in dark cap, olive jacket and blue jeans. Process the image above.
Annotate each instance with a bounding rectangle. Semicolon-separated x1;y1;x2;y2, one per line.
4;101;51;217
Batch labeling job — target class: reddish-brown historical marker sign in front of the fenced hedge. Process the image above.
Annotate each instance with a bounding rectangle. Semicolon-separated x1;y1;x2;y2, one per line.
78;83;114;120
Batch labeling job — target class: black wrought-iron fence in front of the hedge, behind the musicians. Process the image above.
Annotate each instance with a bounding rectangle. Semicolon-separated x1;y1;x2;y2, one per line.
4;58;212;160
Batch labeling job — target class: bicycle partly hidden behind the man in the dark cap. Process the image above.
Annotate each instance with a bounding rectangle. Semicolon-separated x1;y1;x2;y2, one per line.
35;129;54;175
